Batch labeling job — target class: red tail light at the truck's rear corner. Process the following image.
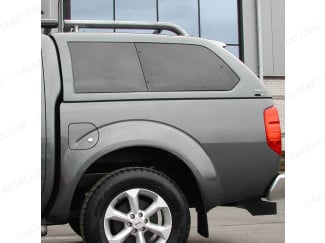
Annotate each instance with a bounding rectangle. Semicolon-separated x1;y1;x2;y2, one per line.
264;106;281;155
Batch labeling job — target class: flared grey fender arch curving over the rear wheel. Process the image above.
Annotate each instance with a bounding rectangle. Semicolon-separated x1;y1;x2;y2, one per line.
47;120;223;236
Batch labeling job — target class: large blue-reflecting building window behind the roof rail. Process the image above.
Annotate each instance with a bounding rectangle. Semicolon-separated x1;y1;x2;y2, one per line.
64;0;240;57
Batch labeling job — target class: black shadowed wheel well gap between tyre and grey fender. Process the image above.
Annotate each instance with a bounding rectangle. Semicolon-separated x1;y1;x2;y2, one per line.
74;146;204;207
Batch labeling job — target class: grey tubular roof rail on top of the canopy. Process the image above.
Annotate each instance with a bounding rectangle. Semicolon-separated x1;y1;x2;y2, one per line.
63;19;188;36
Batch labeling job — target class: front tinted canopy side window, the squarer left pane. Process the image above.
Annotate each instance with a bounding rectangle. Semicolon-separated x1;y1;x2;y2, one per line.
69;42;147;93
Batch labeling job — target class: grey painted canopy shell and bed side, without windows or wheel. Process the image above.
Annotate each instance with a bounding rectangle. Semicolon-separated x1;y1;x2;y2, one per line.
42;33;278;223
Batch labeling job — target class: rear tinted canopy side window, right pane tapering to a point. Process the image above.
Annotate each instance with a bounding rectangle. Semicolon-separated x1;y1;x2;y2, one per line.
136;43;239;91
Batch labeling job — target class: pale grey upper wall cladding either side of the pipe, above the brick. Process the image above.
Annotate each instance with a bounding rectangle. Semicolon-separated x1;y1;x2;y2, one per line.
242;0;285;76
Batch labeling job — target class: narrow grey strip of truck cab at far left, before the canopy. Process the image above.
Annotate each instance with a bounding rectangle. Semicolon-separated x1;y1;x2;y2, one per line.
41;35;61;214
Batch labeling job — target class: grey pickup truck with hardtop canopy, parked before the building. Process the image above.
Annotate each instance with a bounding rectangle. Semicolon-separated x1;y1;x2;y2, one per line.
41;20;282;243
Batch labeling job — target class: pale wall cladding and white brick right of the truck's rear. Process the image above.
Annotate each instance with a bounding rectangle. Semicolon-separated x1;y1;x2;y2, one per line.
242;0;285;150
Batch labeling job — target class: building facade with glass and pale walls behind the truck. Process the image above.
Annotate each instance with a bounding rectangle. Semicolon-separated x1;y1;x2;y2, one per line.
42;0;285;150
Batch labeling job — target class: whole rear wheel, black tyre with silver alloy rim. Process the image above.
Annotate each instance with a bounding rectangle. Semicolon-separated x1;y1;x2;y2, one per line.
80;167;190;243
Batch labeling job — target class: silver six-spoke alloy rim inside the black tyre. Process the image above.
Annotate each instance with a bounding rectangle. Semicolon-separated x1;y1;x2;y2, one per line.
104;188;172;243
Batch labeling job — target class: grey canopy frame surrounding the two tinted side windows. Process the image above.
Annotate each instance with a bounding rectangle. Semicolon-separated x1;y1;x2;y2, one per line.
53;33;246;102
